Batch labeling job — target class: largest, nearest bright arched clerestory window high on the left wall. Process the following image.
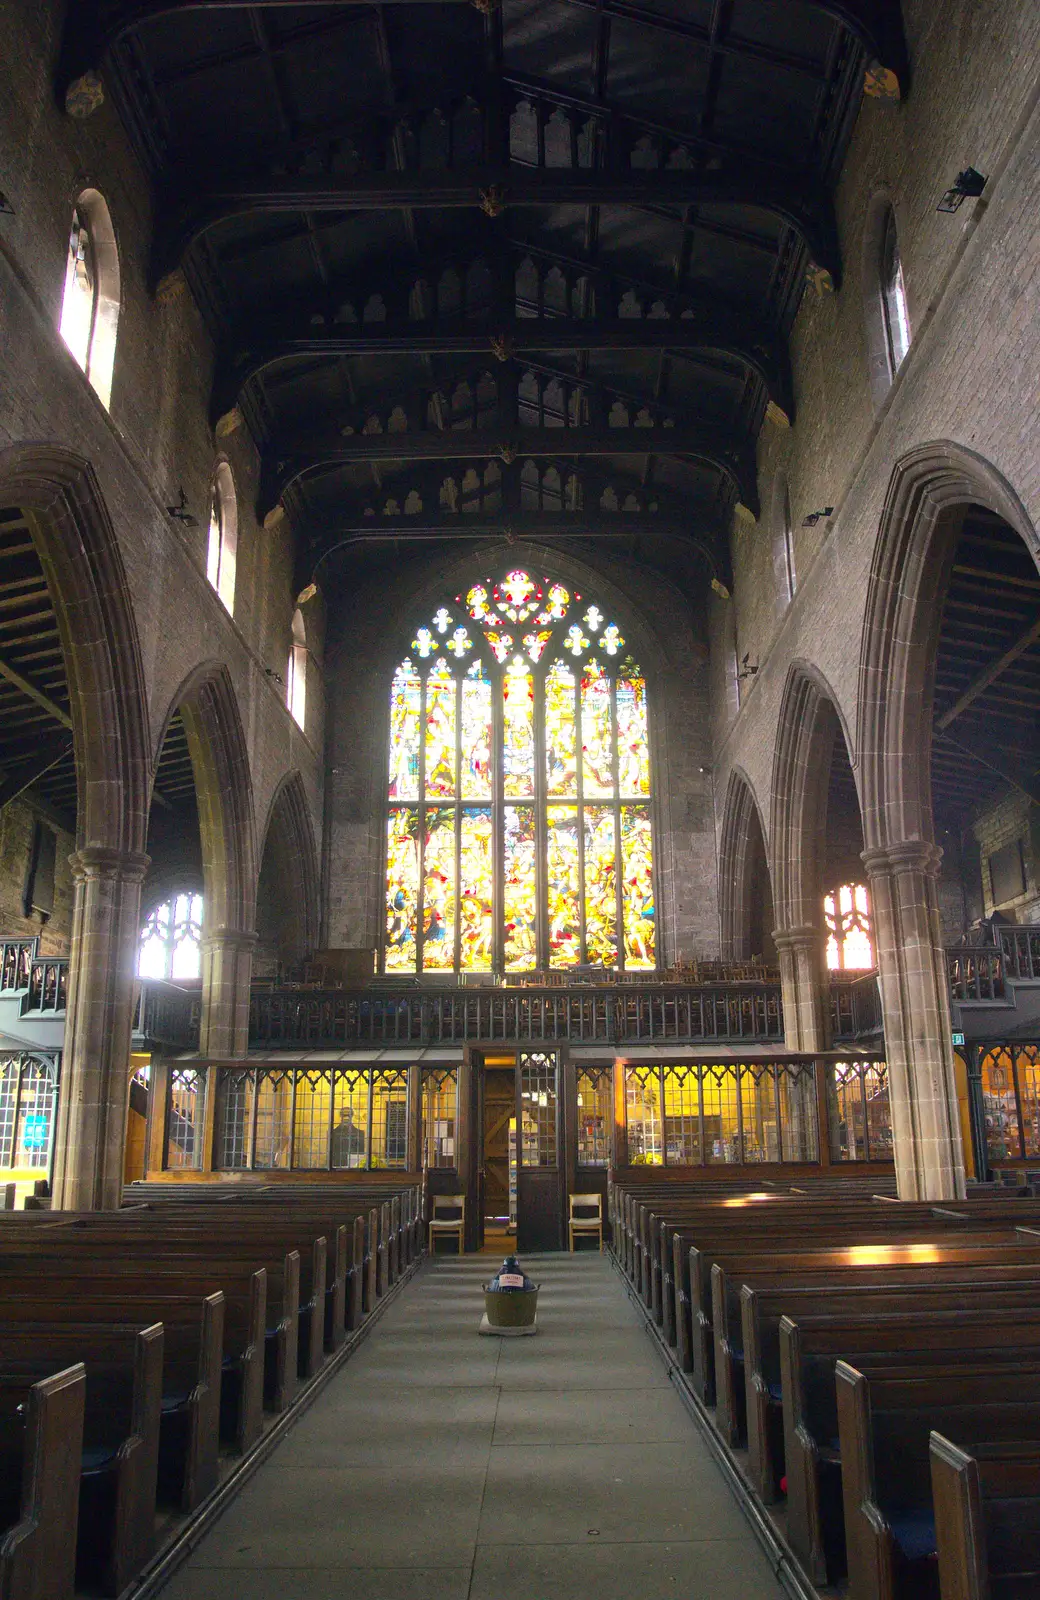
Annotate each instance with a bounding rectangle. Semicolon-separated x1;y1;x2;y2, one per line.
59;189;120;408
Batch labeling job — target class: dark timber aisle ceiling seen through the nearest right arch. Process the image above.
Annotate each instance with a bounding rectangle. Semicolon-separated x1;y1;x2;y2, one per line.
931;506;1040;832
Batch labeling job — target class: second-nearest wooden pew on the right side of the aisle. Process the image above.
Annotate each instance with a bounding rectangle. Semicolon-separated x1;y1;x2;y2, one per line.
835;1362;1040;1600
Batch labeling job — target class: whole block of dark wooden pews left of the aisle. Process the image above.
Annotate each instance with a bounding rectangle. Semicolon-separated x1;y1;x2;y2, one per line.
0;1178;424;1600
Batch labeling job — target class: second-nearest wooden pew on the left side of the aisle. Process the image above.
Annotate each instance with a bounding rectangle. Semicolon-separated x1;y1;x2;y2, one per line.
0;1322;163;1595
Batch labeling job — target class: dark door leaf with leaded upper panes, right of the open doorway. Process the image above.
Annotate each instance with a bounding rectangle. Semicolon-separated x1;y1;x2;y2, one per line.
517;1050;565;1251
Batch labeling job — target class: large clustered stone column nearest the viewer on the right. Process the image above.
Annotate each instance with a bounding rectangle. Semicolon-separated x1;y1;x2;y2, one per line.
862;838;965;1200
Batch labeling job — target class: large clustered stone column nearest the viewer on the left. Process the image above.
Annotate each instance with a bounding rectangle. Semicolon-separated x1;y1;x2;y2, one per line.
54;845;149;1211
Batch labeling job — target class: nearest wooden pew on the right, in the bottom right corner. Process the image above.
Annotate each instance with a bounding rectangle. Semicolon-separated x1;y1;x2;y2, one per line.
928;1432;1040;1600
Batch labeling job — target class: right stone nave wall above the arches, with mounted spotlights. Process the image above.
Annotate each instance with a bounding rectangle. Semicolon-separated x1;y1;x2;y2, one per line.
710;0;1040;889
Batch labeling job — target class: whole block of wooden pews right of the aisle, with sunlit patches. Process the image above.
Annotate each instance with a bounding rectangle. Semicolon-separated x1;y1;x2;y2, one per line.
608;1174;1040;1600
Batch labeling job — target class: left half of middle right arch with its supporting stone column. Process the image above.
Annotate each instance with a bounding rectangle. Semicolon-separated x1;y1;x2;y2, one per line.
770;661;850;1050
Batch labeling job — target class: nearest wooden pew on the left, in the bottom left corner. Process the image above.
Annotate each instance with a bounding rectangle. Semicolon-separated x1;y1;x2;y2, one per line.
0;1363;86;1600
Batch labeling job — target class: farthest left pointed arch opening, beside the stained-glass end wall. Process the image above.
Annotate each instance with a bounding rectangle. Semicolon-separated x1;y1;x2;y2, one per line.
256;771;320;960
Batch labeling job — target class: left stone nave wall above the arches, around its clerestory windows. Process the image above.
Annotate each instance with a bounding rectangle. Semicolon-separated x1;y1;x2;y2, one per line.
0;0;323;926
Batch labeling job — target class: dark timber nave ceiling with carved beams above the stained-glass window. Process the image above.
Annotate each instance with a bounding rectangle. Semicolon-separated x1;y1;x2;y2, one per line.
59;0;906;595
